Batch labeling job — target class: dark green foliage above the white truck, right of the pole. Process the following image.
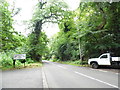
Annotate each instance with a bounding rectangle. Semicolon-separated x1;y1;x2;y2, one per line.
79;2;120;57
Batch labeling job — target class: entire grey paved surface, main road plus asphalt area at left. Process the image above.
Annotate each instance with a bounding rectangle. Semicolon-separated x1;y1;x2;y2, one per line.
2;60;118;90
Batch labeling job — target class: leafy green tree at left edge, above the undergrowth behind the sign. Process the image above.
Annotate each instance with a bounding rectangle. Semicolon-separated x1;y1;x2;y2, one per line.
0;1;24;52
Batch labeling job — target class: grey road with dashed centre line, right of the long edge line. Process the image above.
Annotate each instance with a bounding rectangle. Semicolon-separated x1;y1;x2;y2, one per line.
43;61;118;88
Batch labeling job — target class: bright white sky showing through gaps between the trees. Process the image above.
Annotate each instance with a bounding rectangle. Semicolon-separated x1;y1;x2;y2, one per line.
7;0;80;38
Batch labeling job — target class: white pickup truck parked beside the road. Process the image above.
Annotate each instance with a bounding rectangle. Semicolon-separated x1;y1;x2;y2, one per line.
88;53;120;69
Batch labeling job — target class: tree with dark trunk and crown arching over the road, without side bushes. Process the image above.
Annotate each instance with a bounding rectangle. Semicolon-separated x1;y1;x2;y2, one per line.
27;0;66;61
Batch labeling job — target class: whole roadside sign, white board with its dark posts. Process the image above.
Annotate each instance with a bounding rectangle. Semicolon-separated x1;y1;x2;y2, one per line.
13;54;26;68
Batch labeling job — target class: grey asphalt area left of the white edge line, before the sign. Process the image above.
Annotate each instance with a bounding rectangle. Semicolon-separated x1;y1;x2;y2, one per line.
2;68;42;88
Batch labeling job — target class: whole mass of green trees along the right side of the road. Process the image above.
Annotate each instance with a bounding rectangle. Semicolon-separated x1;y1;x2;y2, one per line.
50;2;120;64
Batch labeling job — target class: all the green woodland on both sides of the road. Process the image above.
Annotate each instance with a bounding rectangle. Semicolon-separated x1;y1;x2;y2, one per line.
0;0;120;66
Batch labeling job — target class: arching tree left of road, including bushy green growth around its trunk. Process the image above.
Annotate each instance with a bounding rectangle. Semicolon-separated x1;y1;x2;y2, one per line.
29;0;67;61
